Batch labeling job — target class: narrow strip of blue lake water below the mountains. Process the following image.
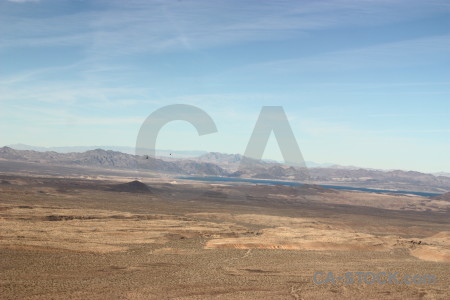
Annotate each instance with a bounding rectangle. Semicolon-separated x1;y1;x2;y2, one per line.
179;176;440;197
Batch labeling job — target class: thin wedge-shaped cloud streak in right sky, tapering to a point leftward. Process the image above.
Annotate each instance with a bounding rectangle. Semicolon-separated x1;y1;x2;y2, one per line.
214;35;450;78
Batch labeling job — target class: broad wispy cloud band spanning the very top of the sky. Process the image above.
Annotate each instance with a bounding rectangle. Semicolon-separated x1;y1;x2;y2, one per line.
0;0;449;57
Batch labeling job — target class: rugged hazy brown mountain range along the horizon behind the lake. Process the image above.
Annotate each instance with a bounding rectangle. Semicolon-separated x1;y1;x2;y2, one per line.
0;147;450;193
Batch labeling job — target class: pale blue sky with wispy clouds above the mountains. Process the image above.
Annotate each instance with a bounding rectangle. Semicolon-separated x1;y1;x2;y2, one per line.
0;0;450;172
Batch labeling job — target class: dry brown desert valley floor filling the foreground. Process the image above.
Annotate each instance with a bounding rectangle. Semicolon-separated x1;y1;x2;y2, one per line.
0;173;450;299
